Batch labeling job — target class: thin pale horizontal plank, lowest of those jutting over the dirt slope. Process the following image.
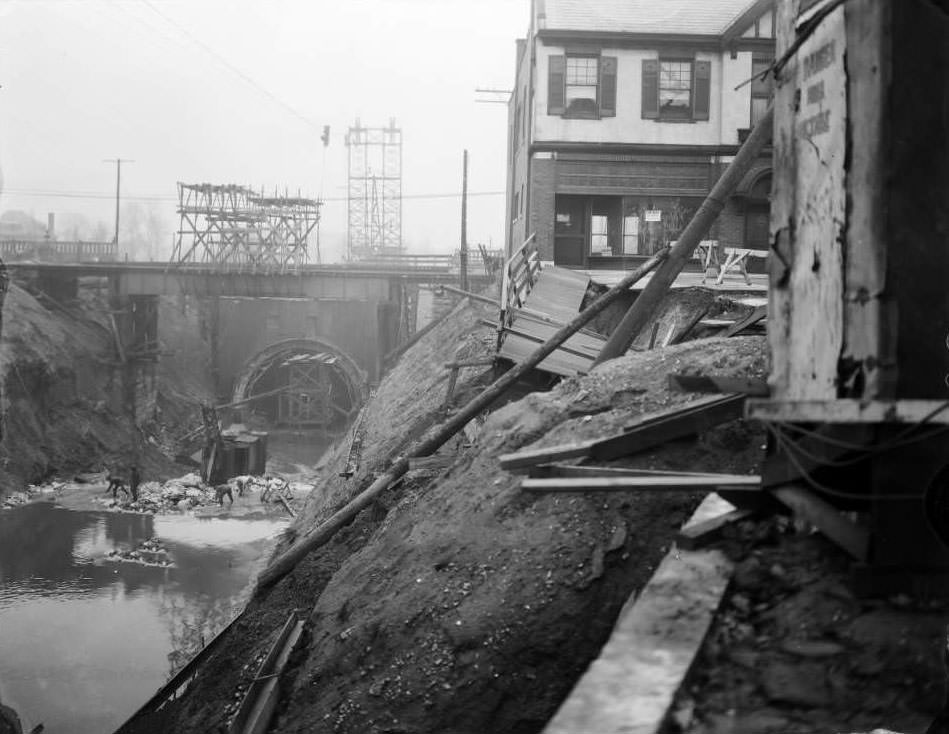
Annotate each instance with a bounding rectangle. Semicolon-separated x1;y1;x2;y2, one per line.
521;474;761;492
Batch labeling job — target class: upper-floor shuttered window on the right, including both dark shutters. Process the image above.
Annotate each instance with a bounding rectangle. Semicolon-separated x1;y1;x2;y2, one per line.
642;59;712;122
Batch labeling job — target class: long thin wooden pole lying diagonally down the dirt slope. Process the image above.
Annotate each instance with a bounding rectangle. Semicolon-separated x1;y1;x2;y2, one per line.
257;248;669;590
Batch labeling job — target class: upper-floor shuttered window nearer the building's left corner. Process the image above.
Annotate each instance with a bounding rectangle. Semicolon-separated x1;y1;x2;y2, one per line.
547;54;616;120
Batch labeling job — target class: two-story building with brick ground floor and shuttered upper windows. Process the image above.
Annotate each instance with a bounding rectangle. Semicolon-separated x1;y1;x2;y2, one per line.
506;0;775;269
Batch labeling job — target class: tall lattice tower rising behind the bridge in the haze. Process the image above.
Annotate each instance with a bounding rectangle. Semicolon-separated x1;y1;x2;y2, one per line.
346;119;402;260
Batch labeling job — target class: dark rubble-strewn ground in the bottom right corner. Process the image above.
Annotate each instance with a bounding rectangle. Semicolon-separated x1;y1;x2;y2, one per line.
681;518;946;734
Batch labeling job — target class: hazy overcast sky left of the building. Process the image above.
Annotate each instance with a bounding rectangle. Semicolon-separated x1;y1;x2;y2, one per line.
0;0;529;259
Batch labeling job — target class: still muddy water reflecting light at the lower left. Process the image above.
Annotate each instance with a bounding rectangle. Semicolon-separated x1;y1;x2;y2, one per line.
0;502;285;734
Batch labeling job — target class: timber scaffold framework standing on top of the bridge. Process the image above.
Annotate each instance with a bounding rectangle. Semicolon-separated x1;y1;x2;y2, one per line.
171;182;323;271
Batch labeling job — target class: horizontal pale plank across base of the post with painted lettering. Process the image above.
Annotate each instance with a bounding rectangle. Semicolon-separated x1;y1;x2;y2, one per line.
745;398;949;425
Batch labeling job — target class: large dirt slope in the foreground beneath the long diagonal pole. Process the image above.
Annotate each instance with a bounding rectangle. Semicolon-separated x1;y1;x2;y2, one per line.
163;288;767;734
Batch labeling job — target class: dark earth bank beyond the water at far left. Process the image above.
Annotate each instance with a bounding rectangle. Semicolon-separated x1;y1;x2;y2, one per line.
0;285;209;494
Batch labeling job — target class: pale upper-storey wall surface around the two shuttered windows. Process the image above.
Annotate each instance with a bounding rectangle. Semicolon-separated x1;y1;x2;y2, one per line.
533;44;752;145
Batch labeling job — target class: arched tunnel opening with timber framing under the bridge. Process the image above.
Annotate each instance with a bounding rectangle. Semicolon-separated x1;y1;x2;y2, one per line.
232;339;369;430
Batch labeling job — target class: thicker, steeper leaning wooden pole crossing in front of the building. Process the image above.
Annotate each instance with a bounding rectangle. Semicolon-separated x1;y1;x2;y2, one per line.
593;105;774;366
